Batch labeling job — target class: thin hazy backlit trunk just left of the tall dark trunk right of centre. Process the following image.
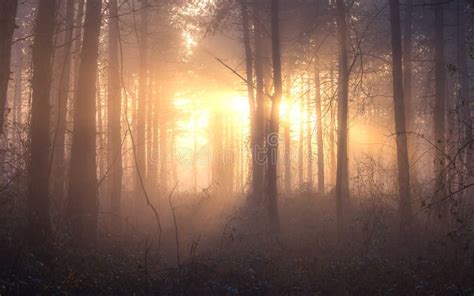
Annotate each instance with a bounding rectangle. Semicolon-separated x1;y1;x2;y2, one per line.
314;59;324;196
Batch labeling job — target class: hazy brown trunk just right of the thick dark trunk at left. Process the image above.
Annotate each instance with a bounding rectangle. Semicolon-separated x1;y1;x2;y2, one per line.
107;0;123;235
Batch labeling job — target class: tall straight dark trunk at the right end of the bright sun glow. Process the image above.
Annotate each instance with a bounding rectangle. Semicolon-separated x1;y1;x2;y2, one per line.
336;0;349;240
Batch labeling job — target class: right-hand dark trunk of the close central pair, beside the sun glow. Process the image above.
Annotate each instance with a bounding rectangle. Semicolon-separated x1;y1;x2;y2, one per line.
266;0;283;232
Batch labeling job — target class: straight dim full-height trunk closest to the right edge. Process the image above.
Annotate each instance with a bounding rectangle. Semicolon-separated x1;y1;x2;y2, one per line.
433;2;447;221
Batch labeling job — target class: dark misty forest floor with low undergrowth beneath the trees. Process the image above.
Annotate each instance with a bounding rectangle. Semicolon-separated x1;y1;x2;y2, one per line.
0;193;474;296
